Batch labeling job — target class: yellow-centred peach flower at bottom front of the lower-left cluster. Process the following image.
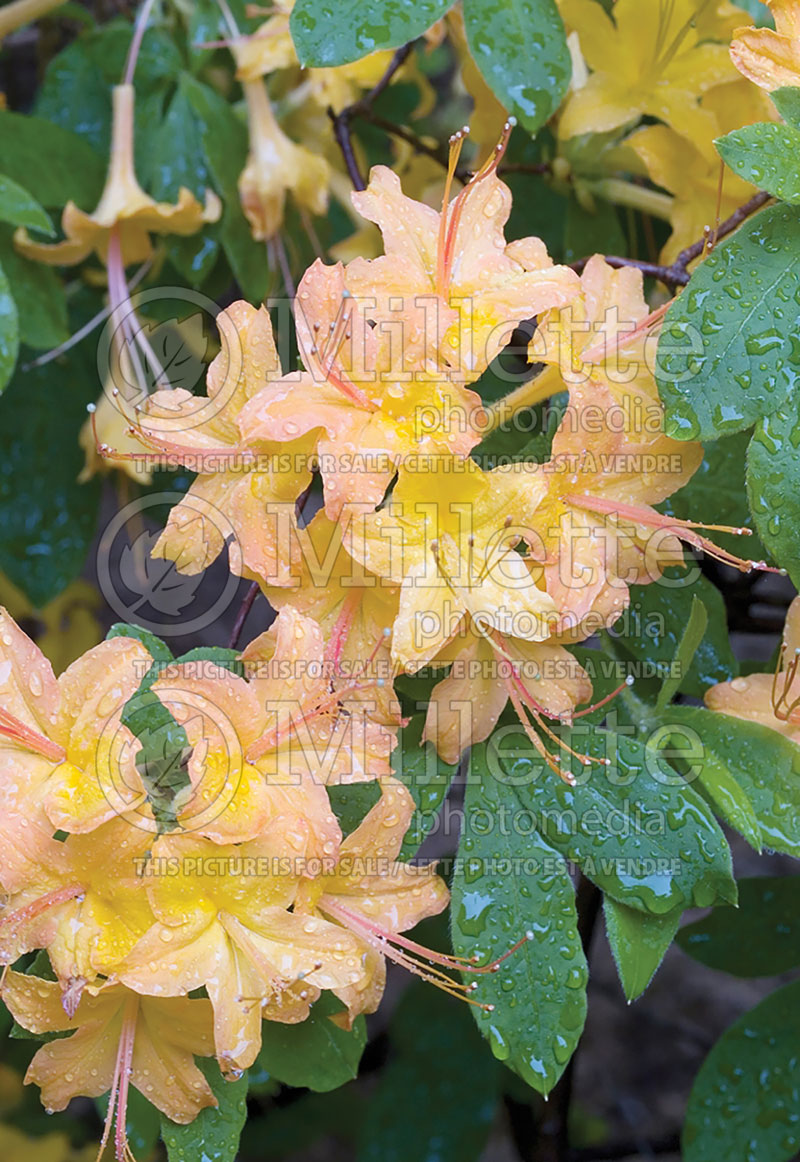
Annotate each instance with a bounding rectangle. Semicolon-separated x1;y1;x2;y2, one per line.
117;819;363;1073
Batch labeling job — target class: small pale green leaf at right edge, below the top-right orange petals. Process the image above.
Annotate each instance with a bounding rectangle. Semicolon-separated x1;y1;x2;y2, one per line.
714;121;800;202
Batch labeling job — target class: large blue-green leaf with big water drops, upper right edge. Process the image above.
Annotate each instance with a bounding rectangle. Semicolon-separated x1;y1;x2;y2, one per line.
656;206;800;440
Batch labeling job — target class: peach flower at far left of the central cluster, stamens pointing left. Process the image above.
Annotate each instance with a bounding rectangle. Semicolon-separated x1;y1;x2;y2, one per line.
124;301;312;584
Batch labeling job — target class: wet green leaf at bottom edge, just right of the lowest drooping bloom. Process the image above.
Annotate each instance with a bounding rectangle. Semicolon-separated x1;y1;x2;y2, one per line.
162;1057;248;1162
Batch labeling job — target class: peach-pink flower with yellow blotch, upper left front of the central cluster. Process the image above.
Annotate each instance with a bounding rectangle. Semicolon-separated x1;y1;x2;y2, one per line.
238;259;483;521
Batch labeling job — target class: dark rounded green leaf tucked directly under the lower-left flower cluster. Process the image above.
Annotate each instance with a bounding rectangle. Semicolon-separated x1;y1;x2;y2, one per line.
257;992;366;1093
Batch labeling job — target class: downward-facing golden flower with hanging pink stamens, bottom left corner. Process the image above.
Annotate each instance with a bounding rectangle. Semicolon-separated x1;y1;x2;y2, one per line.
1;971;217;1143
